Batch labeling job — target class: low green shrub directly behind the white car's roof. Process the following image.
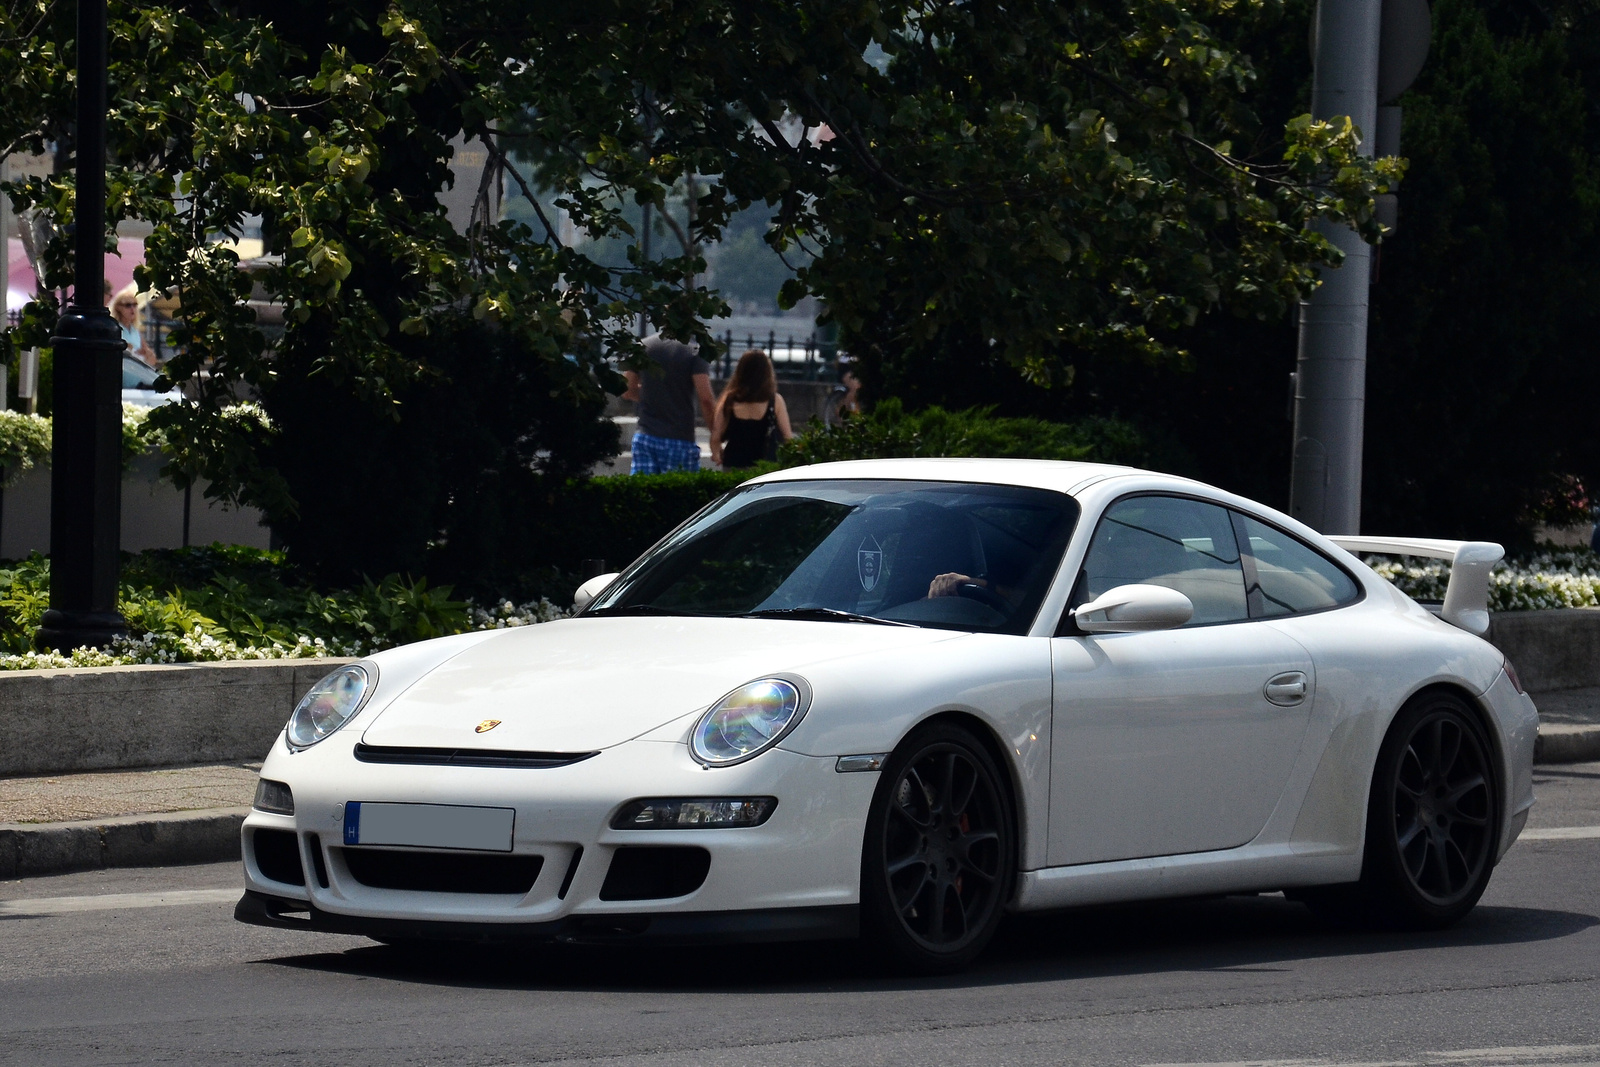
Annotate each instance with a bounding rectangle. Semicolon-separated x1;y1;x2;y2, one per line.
779;398;1150;466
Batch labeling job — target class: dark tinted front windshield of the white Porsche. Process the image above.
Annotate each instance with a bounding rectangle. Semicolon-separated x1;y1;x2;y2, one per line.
586;480;1078;633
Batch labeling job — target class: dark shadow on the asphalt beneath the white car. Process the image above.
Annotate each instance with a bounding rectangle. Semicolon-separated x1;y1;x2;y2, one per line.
259;894;1600;993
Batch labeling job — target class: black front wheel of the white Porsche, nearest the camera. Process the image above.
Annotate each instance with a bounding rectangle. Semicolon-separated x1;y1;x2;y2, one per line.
861;723;1016;974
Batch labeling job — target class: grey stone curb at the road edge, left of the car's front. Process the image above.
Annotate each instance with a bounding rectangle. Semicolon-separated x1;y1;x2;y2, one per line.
0;808;250;878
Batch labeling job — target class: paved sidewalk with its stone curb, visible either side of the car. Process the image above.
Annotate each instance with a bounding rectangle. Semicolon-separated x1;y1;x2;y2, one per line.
0;688;1600;878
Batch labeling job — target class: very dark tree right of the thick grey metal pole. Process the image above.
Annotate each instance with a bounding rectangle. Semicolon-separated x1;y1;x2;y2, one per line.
1363;0;1600;541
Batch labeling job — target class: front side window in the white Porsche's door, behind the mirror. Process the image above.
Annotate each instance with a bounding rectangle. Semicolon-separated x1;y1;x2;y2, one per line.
1072;496;1250;625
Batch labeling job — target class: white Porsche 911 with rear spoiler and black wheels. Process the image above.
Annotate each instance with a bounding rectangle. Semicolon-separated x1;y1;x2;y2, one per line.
237;459;1538;969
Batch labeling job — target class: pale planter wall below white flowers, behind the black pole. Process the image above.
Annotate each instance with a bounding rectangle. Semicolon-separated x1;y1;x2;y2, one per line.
0;453;272;560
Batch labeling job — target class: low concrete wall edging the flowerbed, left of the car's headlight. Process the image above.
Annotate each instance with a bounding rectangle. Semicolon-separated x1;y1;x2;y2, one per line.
0;659;350;777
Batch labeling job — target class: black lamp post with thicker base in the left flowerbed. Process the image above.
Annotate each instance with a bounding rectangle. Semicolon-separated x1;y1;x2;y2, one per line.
37;0;128;651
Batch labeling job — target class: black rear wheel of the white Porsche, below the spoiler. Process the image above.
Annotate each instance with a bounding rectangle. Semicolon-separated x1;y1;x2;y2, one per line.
1362;691;1501;928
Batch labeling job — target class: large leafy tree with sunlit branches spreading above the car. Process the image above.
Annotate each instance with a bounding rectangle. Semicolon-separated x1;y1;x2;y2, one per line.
0;0;1398;585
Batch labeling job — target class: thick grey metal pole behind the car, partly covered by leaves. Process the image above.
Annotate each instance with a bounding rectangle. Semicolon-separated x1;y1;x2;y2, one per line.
1290;0;1382;533
